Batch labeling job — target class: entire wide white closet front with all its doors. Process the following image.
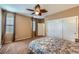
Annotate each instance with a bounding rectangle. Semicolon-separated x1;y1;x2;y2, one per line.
46;16;78;41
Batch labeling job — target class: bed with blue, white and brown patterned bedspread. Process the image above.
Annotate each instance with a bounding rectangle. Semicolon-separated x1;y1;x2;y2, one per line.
28;37;79;54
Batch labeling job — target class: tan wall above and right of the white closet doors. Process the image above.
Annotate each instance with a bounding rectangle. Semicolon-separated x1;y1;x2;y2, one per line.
45;6;79;38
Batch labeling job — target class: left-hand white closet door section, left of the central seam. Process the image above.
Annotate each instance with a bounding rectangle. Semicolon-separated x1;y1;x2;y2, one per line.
46;19;62;39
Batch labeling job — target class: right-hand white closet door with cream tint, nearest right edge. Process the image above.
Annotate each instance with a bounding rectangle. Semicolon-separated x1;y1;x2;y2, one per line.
63;16;78;42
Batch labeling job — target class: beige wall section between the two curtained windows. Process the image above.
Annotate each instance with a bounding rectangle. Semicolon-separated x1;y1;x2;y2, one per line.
15;14;32;40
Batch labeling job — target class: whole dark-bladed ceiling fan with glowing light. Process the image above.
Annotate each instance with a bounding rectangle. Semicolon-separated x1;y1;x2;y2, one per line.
27;4;48;16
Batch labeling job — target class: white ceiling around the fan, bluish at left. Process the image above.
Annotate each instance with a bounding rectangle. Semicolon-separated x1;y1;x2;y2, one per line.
0;4;79;18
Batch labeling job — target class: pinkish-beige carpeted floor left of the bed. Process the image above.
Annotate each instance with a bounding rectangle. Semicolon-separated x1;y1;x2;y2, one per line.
0;39;33;54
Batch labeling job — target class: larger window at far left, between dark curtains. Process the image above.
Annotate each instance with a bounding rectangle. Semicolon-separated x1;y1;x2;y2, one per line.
6;13;14;33
